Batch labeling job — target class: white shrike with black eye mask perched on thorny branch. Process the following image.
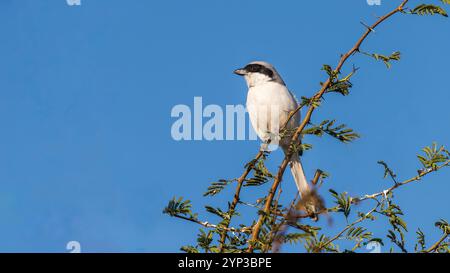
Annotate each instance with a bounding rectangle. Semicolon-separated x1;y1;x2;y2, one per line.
234;62;310;201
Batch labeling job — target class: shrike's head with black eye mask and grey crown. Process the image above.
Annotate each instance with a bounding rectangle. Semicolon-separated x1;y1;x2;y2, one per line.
234;62;285;87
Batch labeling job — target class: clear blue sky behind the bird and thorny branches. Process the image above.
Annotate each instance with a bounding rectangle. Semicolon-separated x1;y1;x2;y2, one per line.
0;0;450;252
